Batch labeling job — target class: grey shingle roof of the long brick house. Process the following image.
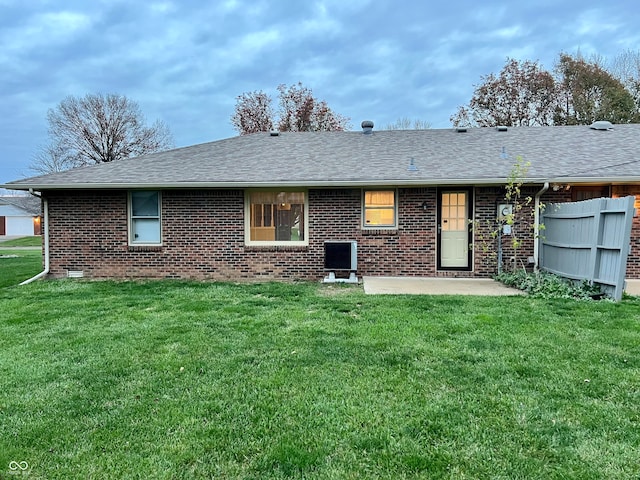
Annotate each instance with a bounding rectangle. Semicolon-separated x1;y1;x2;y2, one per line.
6;125;640;190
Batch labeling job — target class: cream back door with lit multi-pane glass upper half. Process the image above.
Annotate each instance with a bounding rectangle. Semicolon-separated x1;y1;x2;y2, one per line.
438;190;469;269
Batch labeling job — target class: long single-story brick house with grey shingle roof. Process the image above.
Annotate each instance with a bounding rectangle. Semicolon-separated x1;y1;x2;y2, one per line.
4;122;640;280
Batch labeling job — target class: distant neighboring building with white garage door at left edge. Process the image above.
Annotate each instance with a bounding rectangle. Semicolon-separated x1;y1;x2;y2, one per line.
0;196;41;236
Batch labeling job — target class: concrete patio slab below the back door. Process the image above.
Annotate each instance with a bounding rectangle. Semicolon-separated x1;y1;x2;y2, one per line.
362;277;525;296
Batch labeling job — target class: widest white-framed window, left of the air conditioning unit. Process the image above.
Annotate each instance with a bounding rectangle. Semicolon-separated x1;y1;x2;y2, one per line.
245;191;307;245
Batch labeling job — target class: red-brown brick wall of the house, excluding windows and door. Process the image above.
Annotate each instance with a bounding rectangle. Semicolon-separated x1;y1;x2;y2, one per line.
45;187;640;280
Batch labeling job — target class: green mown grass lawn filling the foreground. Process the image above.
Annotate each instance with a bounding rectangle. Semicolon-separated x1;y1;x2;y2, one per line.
0;280;640;479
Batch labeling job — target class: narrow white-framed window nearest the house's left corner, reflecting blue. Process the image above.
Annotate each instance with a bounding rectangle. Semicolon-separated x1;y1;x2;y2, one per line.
129;190;161;245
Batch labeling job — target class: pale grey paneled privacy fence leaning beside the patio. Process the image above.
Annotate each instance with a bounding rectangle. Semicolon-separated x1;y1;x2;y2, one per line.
539;197;635;300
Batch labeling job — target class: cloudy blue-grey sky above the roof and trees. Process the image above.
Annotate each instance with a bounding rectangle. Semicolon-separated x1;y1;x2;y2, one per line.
0;0;640;184
